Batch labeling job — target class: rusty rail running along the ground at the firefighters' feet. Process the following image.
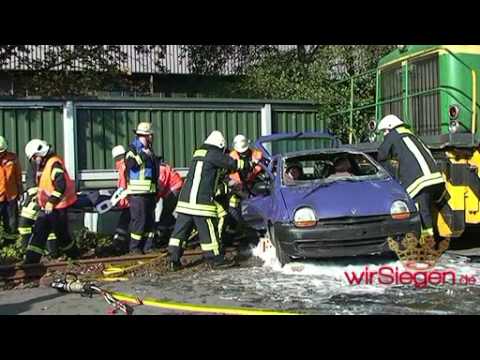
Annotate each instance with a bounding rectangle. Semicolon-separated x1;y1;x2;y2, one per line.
0;247;236;282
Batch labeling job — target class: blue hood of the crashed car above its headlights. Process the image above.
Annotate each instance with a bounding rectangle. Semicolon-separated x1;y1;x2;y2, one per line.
281;179;415;220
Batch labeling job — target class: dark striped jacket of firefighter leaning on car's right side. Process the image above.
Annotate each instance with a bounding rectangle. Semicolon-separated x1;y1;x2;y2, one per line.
377;126;444;198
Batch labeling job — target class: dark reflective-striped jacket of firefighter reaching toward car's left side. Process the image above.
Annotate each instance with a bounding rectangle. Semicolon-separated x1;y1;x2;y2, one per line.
176;145;250;217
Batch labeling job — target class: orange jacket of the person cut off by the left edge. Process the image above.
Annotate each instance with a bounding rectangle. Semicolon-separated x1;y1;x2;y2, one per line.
0;151;23;202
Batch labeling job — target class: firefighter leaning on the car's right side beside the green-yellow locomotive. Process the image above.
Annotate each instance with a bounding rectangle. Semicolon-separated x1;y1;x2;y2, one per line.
377;115;445;239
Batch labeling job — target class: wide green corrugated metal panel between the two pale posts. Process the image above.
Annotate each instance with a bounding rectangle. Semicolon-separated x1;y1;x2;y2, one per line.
77;104;261;171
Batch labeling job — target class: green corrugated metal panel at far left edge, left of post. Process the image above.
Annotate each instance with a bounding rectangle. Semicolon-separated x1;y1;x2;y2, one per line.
0;105;63;169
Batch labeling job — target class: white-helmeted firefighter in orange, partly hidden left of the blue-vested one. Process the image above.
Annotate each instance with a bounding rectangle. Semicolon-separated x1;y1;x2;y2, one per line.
112;145;130;252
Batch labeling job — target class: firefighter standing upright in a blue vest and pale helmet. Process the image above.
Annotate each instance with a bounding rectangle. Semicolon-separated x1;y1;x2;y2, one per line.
125;122;158;254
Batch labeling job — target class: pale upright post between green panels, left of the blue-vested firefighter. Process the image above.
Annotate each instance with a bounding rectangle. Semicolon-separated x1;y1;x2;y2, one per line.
63;101;78;181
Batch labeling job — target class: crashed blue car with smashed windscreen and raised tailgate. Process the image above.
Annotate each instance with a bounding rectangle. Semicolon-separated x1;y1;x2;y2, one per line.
242;133;420;266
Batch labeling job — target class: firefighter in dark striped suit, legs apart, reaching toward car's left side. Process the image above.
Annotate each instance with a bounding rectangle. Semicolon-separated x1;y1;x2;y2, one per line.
168;131;250;271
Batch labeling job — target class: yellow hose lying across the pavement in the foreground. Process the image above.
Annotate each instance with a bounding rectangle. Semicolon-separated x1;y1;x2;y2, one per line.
111;292;301;315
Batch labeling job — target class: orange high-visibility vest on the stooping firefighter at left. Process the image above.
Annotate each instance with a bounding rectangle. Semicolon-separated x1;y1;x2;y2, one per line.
37;155;77;209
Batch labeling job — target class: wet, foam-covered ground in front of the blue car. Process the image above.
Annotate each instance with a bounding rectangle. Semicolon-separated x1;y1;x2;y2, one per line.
0;231;480;315
